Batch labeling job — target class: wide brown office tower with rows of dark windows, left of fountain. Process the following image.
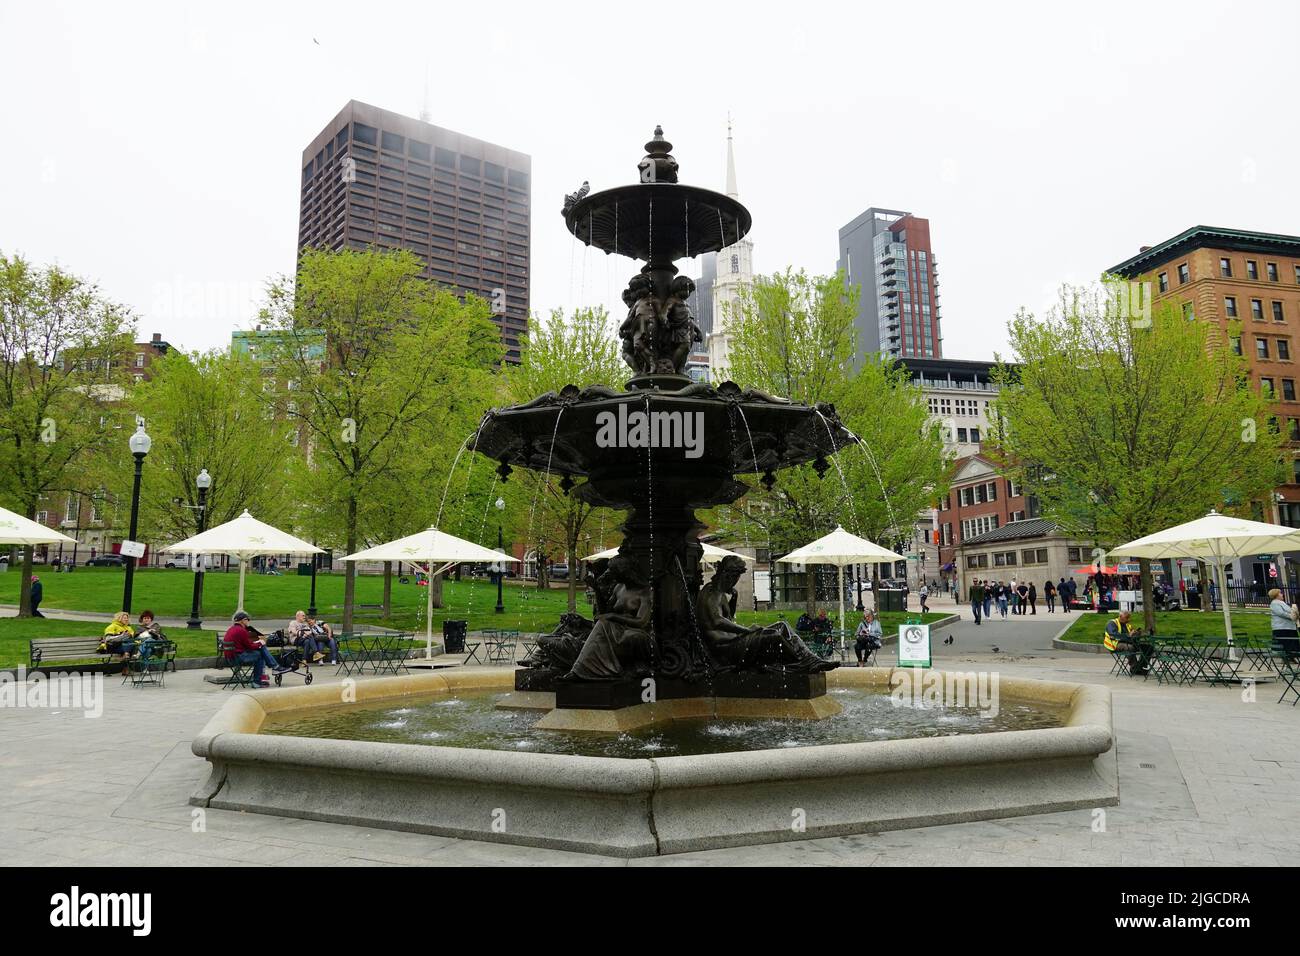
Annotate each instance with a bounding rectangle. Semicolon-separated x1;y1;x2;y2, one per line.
298;100;533;363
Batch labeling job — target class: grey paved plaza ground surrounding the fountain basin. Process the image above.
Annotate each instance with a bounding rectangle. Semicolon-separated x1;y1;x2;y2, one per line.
0;601;1300;866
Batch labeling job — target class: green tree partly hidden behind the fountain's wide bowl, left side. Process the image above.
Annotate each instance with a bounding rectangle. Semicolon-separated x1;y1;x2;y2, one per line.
504;308;631;611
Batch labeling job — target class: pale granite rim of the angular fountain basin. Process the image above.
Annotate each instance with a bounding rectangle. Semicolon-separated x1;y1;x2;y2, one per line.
190;667;1119;857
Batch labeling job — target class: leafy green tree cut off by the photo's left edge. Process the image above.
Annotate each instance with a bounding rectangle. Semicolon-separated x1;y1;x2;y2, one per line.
0;252;135;617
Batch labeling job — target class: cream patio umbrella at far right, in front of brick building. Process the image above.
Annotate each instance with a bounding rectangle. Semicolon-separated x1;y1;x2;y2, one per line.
1108;511;1300;644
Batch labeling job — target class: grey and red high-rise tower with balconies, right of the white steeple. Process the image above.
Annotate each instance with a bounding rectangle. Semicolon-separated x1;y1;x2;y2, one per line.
837;207;944;362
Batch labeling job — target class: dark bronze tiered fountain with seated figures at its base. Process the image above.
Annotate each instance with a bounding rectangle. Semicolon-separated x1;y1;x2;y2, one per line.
471;127;853;730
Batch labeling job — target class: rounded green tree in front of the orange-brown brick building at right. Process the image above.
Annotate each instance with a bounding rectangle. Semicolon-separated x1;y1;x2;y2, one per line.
991;281;1284;628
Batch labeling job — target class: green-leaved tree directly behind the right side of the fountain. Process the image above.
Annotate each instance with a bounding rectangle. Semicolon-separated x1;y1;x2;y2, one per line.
711;269;950;609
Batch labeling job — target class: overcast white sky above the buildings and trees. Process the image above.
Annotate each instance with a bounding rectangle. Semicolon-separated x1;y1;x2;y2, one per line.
0;0;1300;358
